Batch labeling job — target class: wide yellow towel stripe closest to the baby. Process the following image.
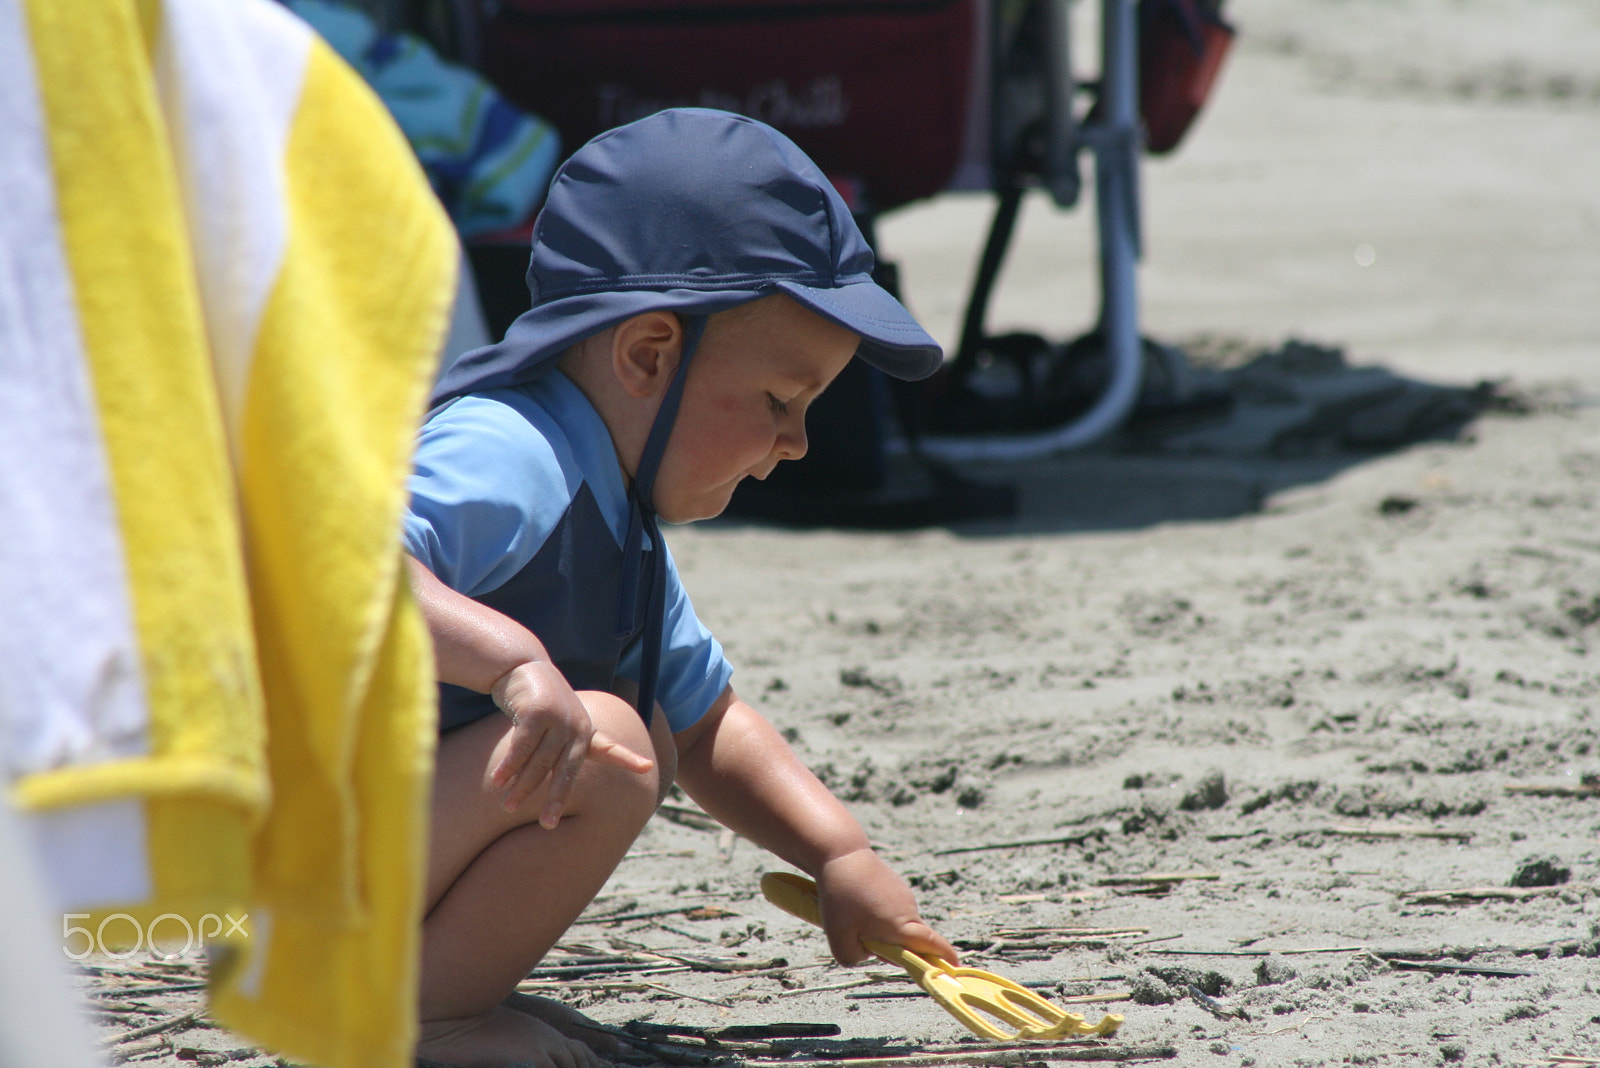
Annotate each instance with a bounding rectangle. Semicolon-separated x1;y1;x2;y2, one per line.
213;42;456;1066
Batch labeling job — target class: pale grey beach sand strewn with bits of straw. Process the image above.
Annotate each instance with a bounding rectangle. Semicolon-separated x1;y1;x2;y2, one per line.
84;0;1600;1066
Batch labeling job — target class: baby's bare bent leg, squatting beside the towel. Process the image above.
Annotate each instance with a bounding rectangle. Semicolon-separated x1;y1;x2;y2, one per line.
418;692;675;1068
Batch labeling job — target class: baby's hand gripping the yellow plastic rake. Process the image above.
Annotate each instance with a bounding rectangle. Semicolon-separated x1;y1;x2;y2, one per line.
816;849;957;964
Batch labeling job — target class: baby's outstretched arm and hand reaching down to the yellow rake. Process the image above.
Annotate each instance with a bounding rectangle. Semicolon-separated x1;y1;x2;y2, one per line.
677;689;955;964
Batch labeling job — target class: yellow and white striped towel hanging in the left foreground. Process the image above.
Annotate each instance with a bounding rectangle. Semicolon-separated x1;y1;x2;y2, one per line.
0;0;456;1068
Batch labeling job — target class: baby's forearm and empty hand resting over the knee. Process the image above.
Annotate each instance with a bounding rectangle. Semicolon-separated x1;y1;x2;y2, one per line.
406;556;654;828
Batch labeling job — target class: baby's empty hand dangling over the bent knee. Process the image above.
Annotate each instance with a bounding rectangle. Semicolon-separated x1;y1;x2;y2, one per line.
488;660;654;830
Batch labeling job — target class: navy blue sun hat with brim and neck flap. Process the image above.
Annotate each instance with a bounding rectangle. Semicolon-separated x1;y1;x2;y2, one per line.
434;107;942;404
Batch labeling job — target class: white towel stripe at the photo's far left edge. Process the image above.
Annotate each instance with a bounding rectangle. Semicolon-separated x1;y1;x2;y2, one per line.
0;0;149;782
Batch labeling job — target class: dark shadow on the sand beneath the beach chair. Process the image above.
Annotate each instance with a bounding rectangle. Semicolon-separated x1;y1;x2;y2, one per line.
718;339;1530;537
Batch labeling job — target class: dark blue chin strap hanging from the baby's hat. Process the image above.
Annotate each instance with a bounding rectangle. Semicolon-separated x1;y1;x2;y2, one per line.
616;315;707;724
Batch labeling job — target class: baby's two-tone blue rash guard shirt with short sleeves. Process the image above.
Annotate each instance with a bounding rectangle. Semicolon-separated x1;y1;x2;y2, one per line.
405;369;733;732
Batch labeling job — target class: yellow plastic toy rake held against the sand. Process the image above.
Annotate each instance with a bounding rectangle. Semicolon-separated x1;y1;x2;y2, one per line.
762;871;1122;1042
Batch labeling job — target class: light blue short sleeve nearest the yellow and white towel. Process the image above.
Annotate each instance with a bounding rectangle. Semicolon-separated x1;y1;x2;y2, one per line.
403;395;579;596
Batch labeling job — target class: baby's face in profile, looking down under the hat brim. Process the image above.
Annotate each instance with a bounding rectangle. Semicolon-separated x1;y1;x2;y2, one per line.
654;296;861;523
